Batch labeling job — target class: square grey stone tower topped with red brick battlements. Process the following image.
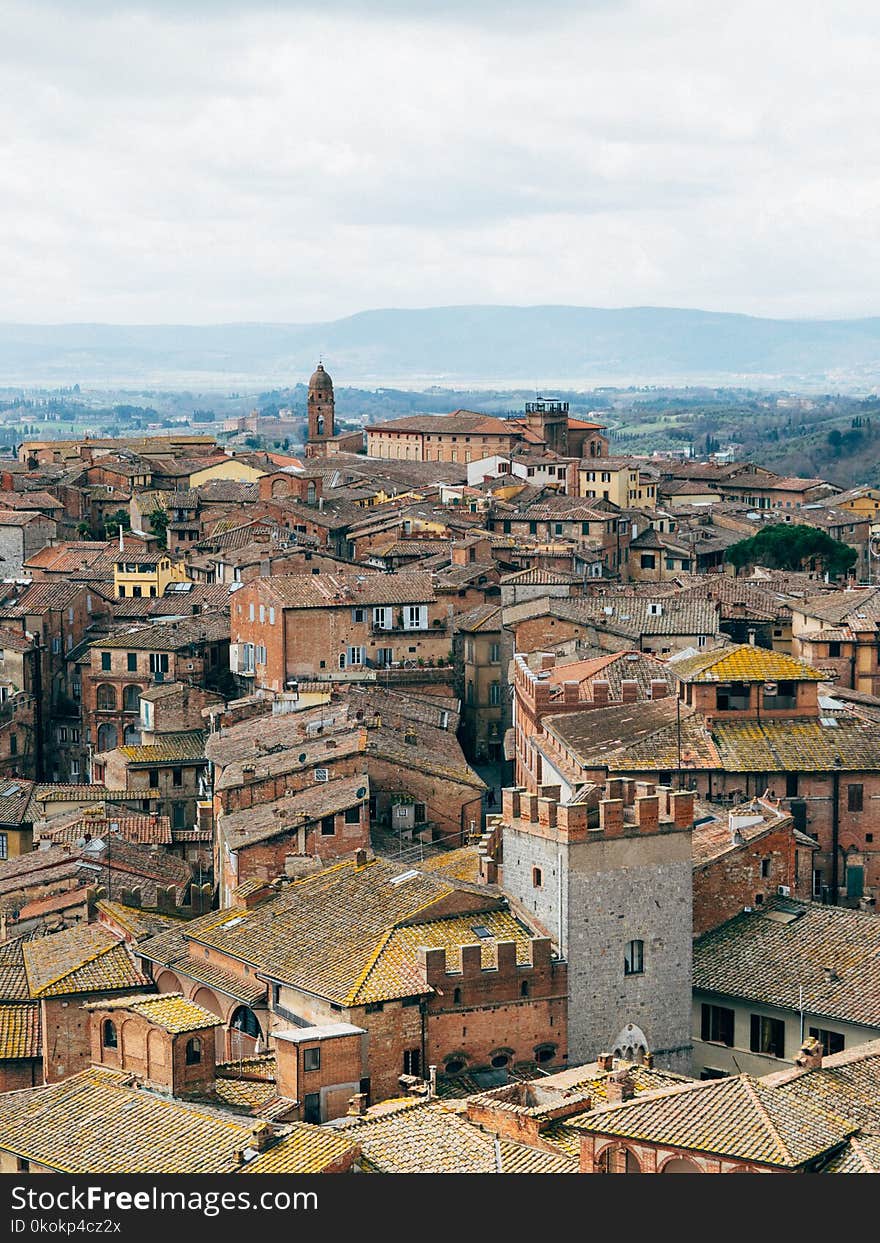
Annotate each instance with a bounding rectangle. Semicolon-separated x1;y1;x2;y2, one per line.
501;778;694;1074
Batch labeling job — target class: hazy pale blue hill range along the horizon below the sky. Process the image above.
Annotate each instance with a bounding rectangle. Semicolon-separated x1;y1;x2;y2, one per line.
0;306;880;390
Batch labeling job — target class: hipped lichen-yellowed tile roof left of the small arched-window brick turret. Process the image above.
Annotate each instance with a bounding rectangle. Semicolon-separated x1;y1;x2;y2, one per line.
24;924;152;997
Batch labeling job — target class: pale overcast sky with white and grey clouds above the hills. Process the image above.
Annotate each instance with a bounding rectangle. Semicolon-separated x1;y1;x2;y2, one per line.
0;0;880;323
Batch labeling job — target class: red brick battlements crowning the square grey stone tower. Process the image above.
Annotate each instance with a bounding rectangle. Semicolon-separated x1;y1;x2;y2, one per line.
501;777;694;842
